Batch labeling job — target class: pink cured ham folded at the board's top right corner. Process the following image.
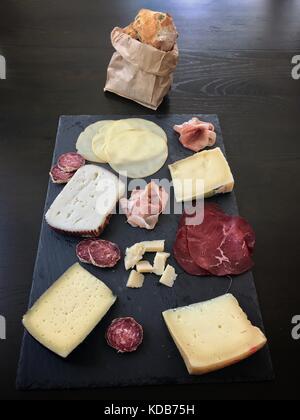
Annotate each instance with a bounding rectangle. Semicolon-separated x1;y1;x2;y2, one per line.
174;117;217;152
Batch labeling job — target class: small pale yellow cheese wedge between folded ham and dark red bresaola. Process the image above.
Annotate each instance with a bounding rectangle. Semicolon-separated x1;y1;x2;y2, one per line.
169;147;234;202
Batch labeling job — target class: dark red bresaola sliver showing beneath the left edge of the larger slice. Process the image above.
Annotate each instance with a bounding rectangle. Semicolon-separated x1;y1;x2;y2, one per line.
173;226;210;276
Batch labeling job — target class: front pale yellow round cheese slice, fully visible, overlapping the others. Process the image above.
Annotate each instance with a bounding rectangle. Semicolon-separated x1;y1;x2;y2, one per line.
105;130;168;178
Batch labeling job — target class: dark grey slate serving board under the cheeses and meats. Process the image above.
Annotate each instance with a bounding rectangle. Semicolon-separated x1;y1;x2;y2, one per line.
17;115;274;389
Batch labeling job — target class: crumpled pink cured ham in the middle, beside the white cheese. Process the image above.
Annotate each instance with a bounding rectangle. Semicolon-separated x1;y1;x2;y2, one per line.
120;182;169;230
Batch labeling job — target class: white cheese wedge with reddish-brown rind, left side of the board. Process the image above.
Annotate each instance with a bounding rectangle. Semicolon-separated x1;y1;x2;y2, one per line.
46;165;125;236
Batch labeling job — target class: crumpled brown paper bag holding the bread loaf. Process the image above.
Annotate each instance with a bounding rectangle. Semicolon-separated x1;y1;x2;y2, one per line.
104;28;178;110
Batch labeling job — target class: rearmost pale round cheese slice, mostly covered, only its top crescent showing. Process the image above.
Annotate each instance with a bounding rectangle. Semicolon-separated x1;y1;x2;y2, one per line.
106;118;168;142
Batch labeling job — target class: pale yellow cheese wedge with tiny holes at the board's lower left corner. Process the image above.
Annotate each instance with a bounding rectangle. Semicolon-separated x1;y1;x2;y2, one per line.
23;264;116;358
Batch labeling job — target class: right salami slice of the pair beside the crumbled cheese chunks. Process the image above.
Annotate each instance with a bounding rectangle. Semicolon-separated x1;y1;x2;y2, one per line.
89;240;121;268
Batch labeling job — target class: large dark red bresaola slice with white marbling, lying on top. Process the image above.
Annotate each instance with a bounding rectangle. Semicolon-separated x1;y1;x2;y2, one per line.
187;204;255;276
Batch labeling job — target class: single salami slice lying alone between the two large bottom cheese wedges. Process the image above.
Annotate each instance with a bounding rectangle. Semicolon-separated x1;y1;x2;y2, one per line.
106;317;144;353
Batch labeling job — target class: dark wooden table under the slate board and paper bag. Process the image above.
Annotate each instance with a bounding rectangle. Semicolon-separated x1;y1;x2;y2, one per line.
0;0;300;400
